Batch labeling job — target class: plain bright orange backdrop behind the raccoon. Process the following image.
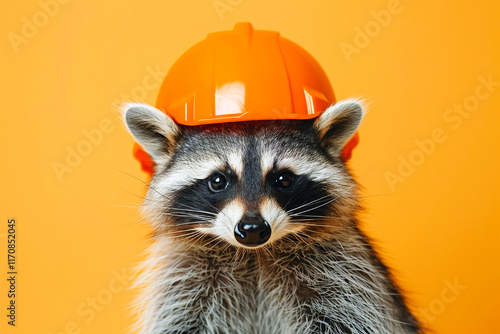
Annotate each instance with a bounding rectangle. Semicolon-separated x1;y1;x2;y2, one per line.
0;0;500;334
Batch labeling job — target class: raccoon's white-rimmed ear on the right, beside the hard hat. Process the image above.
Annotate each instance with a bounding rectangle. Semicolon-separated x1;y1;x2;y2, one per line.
314;99;363;156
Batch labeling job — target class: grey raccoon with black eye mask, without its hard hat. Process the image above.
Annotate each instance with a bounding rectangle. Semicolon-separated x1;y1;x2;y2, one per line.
124;99;421;334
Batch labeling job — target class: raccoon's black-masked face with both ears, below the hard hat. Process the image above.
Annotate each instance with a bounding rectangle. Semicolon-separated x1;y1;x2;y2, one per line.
125;100;363;248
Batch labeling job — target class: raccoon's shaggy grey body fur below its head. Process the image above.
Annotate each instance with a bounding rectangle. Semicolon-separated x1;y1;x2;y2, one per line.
136;232;415;334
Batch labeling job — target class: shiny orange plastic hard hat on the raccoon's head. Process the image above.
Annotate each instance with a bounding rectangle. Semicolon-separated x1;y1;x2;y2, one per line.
134;23;357;174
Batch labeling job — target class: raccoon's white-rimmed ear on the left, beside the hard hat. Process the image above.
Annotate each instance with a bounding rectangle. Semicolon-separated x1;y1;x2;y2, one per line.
123;103;180;162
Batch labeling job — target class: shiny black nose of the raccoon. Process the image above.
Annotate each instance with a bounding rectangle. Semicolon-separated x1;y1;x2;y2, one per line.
234;213;271;247
